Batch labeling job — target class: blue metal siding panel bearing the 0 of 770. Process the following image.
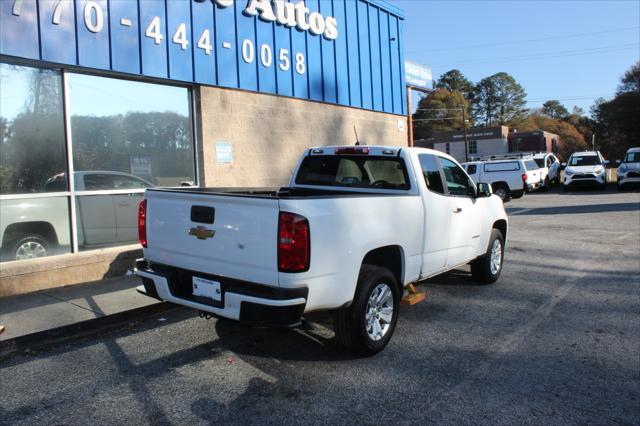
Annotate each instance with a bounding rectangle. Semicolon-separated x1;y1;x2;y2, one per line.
76;0;111;70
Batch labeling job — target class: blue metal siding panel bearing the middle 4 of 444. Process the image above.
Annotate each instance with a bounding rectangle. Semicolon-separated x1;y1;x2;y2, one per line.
167;0;191;81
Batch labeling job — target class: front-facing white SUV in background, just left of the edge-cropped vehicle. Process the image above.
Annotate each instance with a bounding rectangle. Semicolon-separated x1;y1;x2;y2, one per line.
562;151;608;190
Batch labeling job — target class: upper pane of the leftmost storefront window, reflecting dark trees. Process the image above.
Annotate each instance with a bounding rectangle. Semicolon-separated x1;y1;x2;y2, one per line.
0;64;67;194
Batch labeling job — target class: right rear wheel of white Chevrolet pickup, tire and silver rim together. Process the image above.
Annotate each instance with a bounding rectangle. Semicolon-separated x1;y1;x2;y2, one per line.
334;265;401;356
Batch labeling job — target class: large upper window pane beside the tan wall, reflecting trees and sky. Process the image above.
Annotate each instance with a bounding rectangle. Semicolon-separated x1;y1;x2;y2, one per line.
69;74;195;190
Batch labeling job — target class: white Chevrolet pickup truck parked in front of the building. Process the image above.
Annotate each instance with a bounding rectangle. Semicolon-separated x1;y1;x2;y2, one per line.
135;146;507;355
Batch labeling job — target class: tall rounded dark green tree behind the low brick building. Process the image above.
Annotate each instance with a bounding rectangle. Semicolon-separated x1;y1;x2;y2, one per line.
472;72;527;126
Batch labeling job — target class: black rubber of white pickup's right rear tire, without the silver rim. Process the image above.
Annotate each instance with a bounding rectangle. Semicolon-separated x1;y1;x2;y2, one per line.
333;265;402;356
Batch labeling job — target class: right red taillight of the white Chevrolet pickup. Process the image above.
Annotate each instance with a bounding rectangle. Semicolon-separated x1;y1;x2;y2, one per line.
278;212;311;272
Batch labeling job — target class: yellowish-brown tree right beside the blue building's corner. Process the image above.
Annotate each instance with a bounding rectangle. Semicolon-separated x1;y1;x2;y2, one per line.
413;89;469;139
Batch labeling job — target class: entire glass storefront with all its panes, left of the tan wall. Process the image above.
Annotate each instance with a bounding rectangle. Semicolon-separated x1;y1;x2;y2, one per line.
0;63;196;261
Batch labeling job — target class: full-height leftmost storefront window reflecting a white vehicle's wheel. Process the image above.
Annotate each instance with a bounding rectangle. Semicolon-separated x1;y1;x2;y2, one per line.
0;64;71;261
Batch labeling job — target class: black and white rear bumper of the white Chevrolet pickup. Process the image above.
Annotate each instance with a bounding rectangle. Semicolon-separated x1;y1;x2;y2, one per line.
134;259;308;326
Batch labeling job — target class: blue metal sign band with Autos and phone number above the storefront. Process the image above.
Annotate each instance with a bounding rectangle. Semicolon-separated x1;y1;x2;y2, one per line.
0;0;404;113
